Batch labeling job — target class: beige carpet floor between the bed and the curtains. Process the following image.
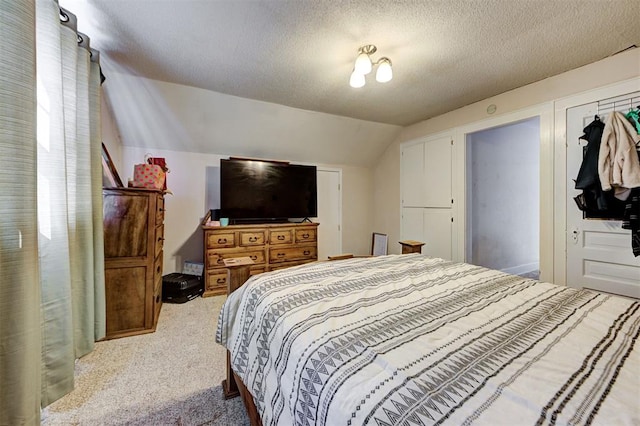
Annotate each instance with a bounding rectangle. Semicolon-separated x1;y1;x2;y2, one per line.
42;296;249;426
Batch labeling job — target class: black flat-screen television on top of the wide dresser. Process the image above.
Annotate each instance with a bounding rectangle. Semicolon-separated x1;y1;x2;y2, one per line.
220;160;318;222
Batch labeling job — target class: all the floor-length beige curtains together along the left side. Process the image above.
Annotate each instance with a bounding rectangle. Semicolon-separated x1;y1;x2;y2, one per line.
0;0;105;425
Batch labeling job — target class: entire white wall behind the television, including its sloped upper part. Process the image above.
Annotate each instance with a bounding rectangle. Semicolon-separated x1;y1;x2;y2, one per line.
97;73;401;273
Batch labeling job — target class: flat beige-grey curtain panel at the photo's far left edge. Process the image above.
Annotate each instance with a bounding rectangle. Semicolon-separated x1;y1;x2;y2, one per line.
0;0;40;425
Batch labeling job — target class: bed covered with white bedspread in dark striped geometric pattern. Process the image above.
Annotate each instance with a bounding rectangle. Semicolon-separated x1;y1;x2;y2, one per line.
216;254;640;426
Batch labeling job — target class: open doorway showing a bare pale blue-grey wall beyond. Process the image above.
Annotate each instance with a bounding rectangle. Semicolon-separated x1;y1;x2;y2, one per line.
465;117;541;279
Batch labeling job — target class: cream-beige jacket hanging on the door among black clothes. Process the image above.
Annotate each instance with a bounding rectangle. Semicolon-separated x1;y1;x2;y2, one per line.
598;111;640;191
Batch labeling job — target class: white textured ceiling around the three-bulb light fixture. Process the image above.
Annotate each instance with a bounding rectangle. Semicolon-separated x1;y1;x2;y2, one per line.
60;0;640;125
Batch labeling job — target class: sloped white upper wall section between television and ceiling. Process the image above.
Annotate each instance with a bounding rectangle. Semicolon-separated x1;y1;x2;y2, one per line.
105;72;402;167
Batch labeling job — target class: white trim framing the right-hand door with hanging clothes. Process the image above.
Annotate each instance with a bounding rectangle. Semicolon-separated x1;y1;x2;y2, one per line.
553;77;640;285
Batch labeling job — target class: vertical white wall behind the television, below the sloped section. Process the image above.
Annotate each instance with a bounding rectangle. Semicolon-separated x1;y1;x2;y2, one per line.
119;146;373;274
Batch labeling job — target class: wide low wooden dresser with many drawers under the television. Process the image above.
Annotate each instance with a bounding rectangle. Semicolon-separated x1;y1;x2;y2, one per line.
202;217;318;297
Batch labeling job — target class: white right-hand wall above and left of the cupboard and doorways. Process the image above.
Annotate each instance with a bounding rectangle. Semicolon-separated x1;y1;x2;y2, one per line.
373;49;640;272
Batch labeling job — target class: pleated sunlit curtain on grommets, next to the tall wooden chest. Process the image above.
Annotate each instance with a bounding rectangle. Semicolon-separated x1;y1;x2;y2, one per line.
36;0;105;406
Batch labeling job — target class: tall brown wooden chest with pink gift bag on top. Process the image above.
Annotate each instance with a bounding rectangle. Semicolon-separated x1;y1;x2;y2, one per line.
102;188;164;339
